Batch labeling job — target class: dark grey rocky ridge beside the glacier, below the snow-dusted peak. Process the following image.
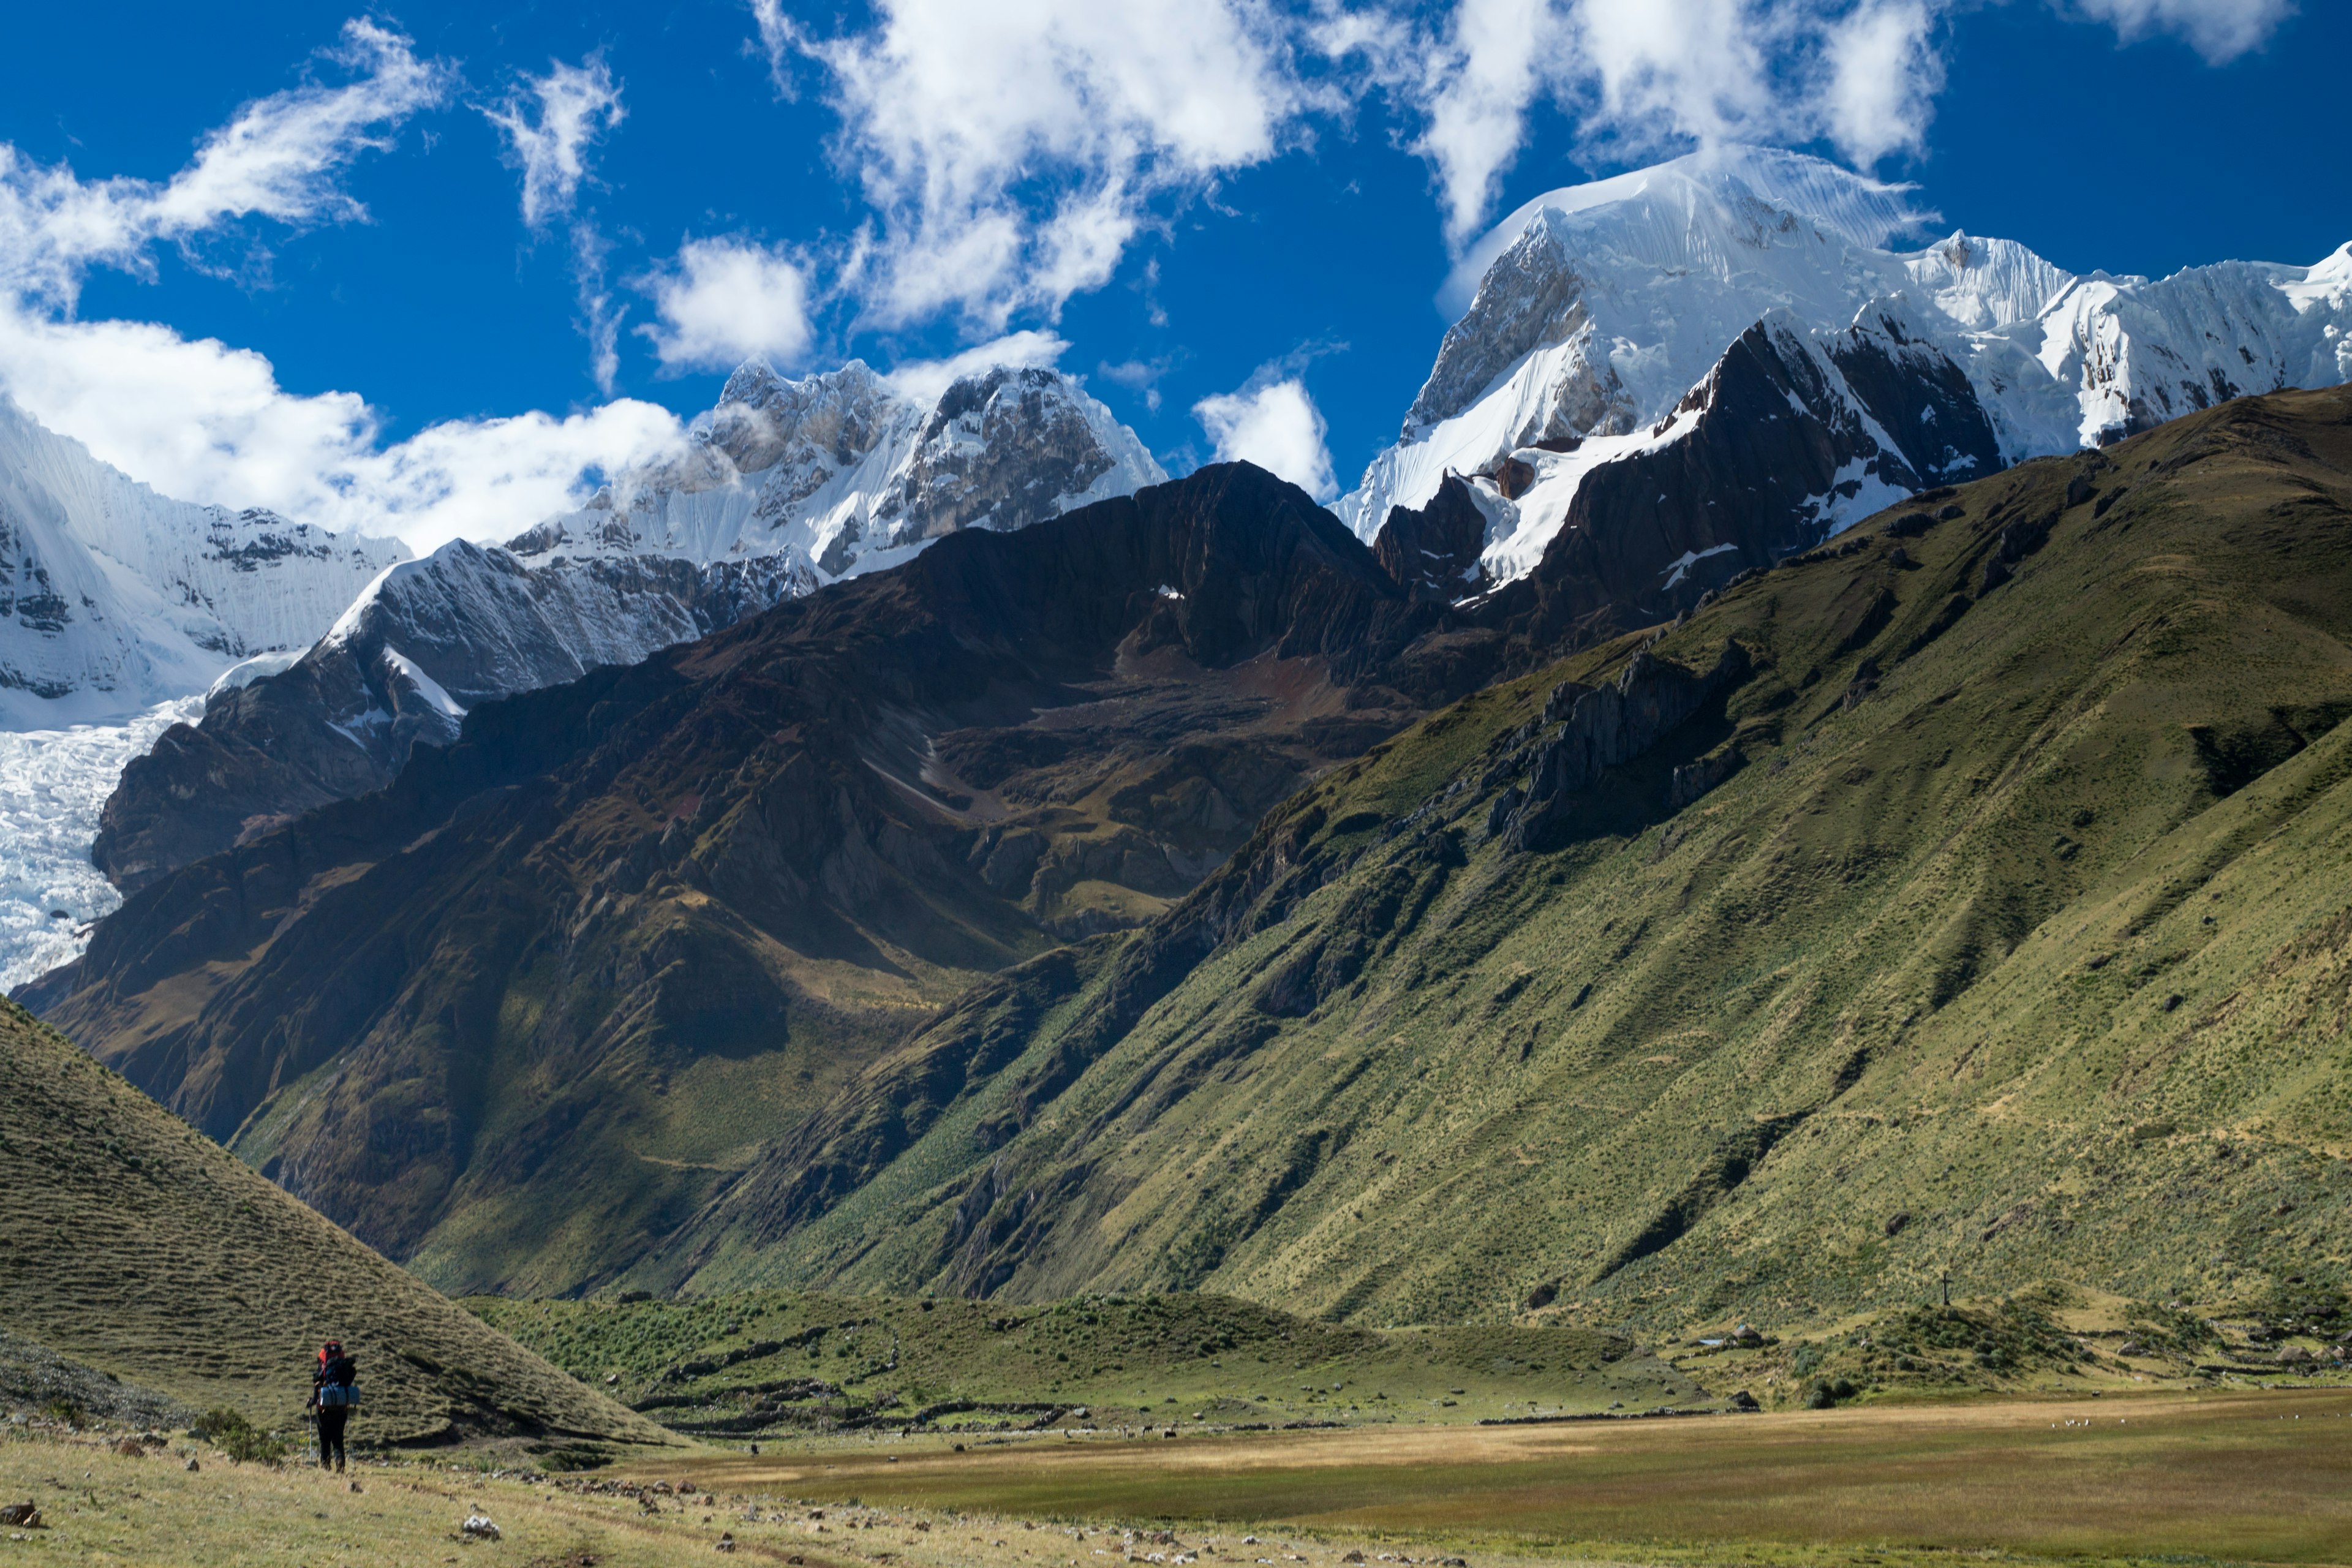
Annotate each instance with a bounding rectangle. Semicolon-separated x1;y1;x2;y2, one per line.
92;541;814;891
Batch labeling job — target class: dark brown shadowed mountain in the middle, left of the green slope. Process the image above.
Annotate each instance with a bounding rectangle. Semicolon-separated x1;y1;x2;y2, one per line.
26;466;1491;1291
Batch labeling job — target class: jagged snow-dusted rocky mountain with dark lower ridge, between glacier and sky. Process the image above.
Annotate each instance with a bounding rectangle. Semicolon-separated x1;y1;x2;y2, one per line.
92;362;1164;891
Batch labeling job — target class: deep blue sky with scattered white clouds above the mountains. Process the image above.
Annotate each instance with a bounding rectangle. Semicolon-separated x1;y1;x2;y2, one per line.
0;0;2352;543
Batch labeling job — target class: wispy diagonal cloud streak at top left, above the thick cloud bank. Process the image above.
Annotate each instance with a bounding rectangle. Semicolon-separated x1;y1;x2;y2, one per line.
0;21;449;311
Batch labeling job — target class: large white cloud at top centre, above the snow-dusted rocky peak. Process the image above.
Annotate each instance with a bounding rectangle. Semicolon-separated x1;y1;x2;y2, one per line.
776;0;1317;329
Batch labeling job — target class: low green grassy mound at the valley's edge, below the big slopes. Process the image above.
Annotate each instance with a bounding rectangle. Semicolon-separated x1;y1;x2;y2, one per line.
466;1291;1708;1436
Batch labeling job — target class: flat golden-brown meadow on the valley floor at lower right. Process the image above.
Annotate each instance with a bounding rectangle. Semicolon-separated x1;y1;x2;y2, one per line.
654;1389;2352;1563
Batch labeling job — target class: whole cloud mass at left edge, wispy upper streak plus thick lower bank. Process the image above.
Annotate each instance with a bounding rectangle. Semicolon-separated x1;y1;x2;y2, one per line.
0;21;682;548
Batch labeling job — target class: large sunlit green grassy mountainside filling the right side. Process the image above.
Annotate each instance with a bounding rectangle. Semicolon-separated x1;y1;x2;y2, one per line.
644;390;2352;1329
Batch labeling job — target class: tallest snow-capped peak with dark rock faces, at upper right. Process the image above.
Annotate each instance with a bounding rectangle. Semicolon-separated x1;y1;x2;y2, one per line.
1338;146;2352;620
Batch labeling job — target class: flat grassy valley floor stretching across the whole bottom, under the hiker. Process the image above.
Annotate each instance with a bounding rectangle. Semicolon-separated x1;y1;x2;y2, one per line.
0;1387;2352;1568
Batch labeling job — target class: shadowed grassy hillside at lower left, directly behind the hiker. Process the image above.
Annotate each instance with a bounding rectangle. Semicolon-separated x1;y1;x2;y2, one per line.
0;1001;666;1444
